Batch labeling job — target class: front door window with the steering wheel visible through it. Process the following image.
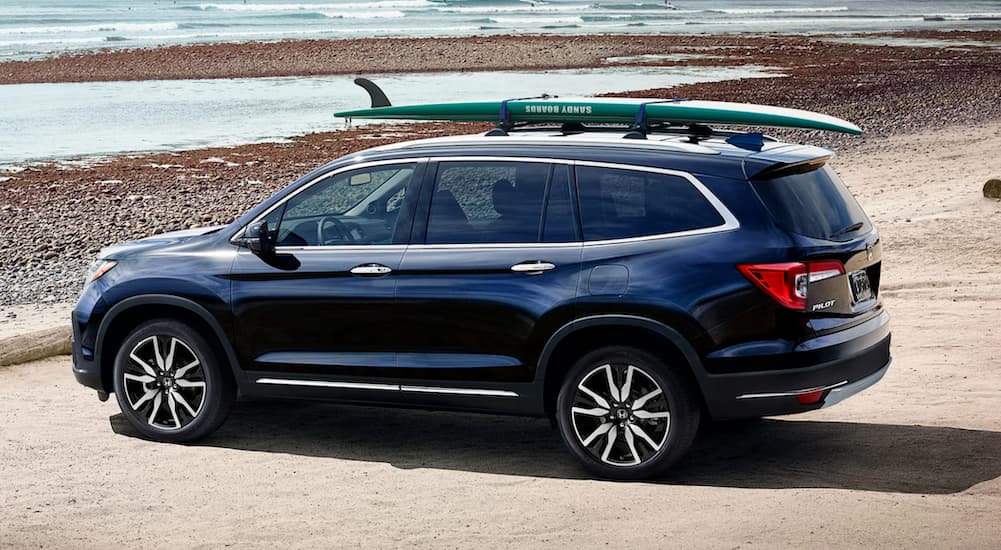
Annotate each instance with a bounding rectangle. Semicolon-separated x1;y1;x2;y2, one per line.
277;163;416;246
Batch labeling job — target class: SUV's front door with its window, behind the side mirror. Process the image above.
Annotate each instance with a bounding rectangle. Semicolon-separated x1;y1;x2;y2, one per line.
232;161;422;380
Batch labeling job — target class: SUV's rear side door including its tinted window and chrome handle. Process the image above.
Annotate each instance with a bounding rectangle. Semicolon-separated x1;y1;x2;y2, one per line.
396;157;582;387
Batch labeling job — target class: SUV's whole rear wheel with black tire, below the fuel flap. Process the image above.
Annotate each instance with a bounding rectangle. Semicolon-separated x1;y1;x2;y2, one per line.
557;347;701;480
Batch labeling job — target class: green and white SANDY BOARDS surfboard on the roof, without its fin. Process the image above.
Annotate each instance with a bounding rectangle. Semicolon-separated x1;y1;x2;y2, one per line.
334;98;862;135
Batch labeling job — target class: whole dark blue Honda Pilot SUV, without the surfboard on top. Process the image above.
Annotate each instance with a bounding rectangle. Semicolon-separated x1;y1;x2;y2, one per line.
73;129;890;478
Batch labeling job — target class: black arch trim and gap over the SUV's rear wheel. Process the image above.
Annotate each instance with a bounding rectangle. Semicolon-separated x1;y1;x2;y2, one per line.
537;314;707;417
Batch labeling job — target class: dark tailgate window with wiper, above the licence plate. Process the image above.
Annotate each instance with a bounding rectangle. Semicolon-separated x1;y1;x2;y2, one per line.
751;166;871;240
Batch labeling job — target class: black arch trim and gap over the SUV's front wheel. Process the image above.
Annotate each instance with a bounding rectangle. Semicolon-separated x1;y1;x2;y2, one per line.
94;295;240;393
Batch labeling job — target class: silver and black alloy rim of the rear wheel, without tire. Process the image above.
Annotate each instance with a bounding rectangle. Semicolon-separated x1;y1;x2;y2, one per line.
571;364;671;466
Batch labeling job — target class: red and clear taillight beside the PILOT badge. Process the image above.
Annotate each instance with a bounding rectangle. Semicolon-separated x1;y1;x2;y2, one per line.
737;260;845;311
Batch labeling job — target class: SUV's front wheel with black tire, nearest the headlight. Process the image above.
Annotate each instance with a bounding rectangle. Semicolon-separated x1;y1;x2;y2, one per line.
114;319;236;443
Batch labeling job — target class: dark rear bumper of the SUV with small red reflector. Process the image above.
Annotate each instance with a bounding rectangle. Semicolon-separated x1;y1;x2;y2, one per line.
700;312;891;419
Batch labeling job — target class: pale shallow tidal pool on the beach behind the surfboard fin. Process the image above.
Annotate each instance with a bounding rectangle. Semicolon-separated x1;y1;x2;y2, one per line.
0;66;781;164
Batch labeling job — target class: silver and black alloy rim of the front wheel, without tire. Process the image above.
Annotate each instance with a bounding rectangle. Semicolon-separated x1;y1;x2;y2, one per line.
121;336;206;430
